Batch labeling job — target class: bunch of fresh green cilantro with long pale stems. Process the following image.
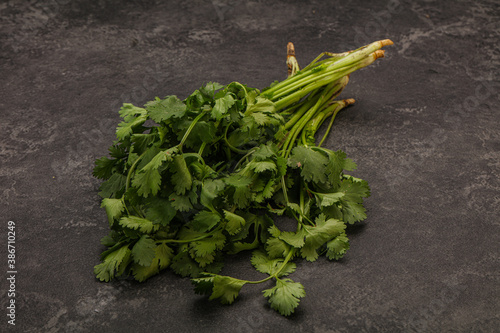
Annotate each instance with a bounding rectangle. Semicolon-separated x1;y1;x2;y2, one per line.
93;40;392;316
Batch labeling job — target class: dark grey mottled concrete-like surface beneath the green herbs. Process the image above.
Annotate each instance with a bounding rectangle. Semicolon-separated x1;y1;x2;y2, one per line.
0;0;500;332
